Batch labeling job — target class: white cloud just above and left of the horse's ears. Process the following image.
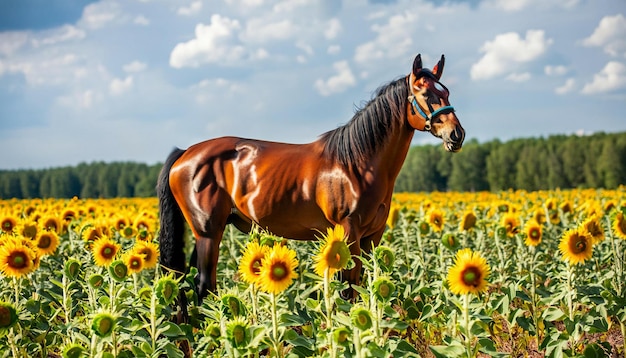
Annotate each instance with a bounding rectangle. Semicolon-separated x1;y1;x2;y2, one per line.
354;11;416;63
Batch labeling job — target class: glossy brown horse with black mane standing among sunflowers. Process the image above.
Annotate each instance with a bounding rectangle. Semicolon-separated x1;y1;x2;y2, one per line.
157;55;465;299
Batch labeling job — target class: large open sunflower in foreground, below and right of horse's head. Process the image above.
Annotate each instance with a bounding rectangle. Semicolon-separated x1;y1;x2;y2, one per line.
448;248;490;295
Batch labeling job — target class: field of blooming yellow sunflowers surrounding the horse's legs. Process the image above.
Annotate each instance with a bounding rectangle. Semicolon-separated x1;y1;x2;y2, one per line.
0;187;626;358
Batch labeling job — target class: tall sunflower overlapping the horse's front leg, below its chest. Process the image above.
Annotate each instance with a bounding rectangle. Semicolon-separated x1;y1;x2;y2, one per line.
313;225;351;277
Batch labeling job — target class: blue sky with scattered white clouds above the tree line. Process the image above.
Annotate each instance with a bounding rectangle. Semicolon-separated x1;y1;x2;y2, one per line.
0;0;626;169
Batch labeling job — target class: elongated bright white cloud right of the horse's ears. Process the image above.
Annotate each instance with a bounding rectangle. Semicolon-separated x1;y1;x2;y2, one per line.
470;30;552;80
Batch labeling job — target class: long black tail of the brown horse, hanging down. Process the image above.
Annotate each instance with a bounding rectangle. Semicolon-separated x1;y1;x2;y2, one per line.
156;148;186;274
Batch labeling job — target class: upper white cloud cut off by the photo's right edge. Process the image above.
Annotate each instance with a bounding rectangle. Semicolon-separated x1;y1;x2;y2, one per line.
583;14;626;57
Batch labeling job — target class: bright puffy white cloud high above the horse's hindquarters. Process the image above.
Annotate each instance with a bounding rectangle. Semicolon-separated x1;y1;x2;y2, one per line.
170;14;246;68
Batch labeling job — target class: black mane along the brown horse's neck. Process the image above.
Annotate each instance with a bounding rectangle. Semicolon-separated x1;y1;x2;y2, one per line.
320;77;409;166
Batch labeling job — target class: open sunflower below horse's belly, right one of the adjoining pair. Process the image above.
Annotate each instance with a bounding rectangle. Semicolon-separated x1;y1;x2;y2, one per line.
259;244;298;294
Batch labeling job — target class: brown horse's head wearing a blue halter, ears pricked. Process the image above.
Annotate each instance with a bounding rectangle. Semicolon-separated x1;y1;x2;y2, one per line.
407;55;465;152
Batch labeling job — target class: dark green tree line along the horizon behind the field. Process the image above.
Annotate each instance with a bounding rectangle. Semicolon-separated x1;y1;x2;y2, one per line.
0;132;626;199
